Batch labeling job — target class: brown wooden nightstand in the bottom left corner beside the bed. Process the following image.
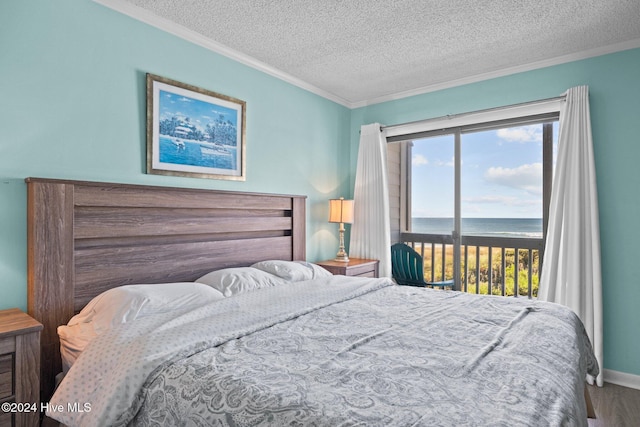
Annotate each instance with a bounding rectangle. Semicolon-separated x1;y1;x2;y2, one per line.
0;308;42;427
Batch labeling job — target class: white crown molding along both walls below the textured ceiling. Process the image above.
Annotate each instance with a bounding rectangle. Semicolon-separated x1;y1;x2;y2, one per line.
93;0;640;109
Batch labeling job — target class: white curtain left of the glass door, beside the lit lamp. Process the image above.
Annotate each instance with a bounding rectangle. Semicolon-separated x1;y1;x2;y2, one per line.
349;123;391;277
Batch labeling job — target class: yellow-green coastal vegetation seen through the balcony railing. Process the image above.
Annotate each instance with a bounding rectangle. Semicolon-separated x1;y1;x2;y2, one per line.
415;244;540;298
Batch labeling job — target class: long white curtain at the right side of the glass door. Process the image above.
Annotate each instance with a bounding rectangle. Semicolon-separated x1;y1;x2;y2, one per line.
538;86;604;386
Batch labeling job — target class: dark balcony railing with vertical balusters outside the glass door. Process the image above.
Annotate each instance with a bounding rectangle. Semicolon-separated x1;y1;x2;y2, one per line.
401;233;544;298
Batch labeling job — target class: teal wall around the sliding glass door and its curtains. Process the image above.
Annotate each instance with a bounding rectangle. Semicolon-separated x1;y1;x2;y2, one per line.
350;49;640;375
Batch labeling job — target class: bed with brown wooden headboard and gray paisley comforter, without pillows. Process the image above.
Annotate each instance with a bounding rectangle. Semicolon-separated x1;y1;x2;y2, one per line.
27;179;598;426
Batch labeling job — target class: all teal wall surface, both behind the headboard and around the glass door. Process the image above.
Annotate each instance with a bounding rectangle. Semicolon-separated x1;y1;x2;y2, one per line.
0;0;640;382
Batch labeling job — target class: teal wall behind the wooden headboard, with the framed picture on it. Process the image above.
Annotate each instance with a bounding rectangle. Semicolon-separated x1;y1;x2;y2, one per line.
0;0;350;309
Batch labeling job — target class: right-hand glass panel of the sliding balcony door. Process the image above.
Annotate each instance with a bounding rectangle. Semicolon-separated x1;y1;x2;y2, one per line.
460;124;544;295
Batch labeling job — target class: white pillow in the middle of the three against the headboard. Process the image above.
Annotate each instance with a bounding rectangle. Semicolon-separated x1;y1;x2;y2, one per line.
196;267;286;297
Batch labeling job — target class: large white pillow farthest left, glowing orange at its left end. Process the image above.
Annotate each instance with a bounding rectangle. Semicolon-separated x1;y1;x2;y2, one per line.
58;282;224;372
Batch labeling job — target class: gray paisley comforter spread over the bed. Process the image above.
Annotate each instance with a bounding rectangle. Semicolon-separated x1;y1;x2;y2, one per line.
49;276;598;427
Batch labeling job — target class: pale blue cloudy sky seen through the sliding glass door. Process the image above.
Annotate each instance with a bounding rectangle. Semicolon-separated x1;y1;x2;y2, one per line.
411;122;558;218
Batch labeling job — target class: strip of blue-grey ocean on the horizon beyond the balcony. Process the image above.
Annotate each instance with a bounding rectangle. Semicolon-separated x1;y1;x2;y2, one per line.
411;218;542;238
